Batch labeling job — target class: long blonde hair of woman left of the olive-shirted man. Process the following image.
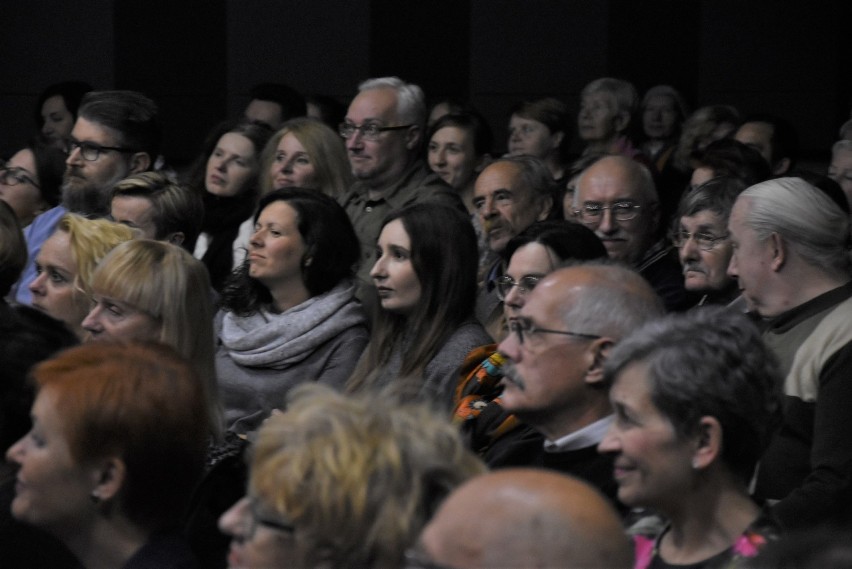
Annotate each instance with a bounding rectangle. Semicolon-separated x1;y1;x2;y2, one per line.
260;117;355;199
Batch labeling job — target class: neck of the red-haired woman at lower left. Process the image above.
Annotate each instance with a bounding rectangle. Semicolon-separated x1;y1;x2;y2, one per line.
63;515;149;569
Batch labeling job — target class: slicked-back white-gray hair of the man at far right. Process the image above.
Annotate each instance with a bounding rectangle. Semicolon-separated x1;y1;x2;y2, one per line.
738;178;852;276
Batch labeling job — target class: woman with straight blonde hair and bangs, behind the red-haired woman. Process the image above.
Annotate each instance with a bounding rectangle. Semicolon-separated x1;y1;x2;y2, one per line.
82;239;222;435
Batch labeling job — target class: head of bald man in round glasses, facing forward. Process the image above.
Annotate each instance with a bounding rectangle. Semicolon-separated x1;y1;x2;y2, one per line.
574;156;660;264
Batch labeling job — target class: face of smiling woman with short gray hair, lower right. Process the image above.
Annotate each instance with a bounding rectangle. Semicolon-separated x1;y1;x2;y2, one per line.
598;361;695;511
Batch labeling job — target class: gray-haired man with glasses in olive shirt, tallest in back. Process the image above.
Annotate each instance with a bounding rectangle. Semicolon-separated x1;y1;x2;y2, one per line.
339;77;466;290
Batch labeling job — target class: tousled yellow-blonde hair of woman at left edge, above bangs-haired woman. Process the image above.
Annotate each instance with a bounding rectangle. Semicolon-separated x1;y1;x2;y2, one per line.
54;213;138;296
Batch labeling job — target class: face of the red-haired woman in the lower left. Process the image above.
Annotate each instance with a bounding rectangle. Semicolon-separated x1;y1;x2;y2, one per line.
6;387;100;533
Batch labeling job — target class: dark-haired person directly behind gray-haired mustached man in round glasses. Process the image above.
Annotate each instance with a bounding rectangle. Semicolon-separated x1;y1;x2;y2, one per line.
689;138;772;188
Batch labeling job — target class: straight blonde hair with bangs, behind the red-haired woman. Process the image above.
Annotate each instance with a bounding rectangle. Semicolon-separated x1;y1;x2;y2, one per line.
91;239;222;436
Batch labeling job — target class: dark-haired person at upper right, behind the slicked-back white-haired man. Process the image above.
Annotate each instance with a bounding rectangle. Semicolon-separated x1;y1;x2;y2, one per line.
734;114;799;177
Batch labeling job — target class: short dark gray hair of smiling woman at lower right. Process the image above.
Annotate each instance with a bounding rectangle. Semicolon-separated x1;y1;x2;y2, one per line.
604;307;782;482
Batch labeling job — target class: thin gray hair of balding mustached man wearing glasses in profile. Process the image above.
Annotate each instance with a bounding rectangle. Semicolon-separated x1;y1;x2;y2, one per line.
562;260;665;341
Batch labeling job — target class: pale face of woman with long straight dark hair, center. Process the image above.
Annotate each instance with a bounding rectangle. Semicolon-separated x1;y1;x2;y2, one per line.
370;219;422;315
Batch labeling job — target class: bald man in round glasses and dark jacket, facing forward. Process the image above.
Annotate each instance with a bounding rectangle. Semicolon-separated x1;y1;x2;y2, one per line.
573;156;695;311
